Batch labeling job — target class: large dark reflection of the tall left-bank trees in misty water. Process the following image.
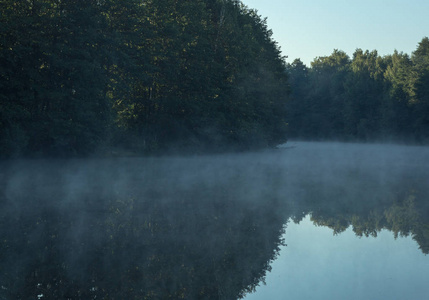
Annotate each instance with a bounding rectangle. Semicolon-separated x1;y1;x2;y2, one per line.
0;158;285;299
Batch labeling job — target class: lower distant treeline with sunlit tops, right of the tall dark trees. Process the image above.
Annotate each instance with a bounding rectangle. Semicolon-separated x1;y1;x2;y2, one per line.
287;37;429;143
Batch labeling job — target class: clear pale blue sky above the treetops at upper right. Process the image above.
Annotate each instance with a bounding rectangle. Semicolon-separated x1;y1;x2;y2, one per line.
242;0;429;66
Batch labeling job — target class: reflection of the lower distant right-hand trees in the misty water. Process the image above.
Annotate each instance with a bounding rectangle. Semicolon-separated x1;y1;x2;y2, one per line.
292;157;429;254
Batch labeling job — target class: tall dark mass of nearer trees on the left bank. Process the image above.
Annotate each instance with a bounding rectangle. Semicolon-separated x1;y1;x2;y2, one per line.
0;0;288;157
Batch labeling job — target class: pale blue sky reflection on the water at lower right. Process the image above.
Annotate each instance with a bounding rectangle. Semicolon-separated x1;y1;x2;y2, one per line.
245;216;429;300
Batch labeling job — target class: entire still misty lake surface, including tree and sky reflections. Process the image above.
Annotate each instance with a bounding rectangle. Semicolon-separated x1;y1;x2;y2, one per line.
0;142;429;299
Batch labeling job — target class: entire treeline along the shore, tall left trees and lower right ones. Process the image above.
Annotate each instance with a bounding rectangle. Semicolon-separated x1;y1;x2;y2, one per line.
0;0;429;158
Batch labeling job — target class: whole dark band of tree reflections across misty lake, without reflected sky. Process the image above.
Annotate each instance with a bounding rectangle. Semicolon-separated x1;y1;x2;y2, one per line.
0;144;429;299
